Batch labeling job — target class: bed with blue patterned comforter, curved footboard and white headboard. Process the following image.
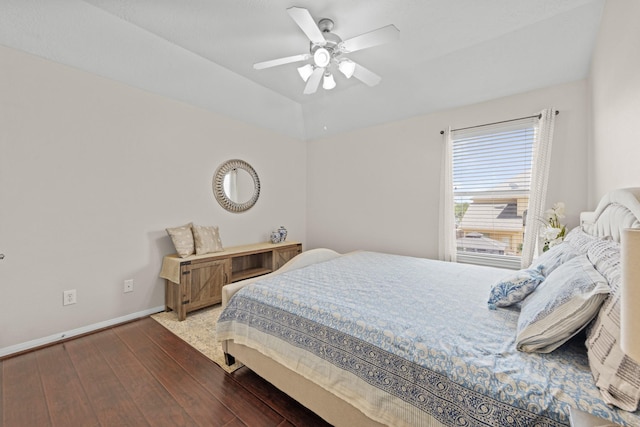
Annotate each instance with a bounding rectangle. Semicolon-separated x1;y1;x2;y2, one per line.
217;189;640;426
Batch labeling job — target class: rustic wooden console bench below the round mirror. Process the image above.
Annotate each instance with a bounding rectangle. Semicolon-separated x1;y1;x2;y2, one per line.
160;242;302;320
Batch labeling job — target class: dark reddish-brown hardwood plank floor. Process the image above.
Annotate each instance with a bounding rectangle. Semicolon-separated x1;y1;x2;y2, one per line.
0;318;328;427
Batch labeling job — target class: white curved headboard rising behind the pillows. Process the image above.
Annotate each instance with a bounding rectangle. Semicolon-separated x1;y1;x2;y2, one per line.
580;187;640;242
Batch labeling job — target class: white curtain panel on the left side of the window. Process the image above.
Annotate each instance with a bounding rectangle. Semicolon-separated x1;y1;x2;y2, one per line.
438;127;456;262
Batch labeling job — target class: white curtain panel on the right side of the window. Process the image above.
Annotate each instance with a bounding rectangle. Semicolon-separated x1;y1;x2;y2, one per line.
521;108;556;268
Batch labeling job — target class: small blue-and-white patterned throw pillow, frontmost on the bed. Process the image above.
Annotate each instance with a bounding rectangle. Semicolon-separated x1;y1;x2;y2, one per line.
488;266;544;310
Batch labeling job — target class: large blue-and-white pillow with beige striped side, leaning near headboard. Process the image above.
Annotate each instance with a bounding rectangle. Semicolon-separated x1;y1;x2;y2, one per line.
516;255;609;353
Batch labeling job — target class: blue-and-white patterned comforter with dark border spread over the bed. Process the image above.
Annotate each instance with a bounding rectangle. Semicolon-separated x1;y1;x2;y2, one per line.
218;252;640;426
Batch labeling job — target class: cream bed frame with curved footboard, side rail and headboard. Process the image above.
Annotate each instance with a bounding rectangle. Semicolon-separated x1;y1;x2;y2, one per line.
222;188;640;427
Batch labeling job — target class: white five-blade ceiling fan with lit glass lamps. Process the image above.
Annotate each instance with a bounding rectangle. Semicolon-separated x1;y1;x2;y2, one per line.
253;7;400;95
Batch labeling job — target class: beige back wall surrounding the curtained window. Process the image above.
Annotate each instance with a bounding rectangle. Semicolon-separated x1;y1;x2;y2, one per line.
307;80;587;258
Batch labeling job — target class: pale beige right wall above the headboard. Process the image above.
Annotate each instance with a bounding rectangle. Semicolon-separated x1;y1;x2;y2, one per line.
589;0;640;208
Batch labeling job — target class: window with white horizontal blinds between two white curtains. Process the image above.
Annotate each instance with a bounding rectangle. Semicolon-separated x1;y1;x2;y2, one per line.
451;117;539;269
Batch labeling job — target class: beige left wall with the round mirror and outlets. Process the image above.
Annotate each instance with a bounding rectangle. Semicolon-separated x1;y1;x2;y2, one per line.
0;47;306;352
